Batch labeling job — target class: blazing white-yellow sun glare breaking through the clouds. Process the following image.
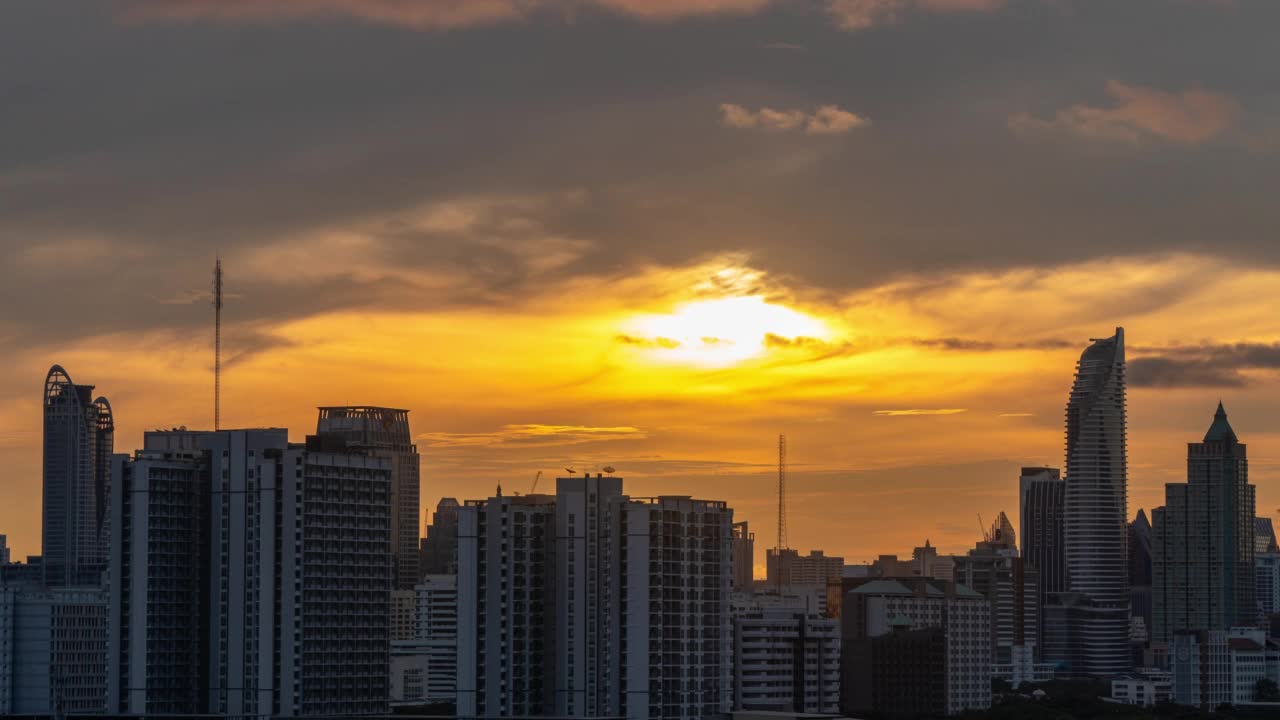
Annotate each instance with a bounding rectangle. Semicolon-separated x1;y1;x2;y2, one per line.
627;295;831;368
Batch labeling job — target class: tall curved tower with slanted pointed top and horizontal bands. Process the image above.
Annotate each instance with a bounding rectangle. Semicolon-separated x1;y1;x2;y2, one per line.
1062;328;1129;676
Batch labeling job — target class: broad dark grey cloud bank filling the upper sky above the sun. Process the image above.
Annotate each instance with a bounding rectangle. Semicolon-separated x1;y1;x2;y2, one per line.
0;0;1280;342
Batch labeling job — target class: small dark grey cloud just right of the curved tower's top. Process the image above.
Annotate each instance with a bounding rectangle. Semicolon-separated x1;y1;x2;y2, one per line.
1129;342;1280;388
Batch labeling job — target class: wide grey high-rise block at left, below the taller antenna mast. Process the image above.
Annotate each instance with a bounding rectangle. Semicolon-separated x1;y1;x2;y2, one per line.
108;429;392;717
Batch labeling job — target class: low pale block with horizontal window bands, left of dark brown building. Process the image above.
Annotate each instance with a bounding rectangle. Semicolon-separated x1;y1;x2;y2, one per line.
733;599;840;714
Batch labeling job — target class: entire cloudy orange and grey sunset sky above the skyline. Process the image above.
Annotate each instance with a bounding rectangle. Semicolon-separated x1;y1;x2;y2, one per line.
0;0;1280;564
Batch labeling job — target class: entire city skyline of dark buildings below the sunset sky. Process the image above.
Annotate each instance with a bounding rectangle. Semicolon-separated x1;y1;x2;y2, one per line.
0;327;1280;717
